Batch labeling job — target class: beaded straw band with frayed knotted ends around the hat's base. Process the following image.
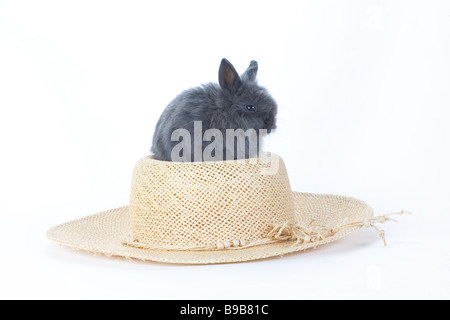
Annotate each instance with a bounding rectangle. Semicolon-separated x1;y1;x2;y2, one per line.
122;211;411;251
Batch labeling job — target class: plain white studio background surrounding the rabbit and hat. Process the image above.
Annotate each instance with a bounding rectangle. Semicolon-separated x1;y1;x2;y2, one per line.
0;0;450;299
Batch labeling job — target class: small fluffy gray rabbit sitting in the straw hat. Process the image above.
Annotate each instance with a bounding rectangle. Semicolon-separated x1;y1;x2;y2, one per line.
151;59;278;162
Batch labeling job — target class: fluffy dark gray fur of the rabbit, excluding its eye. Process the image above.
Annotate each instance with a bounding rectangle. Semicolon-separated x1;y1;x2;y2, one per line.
151;59;278;161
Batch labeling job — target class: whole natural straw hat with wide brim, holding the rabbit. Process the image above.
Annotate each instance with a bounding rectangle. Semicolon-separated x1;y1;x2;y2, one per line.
47;154;403;264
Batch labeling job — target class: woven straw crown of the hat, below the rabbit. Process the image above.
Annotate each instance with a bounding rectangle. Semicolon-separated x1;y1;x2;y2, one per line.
129;153;297;249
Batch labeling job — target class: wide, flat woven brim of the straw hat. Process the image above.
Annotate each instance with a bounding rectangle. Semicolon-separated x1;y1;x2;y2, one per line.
47;192;373;264
